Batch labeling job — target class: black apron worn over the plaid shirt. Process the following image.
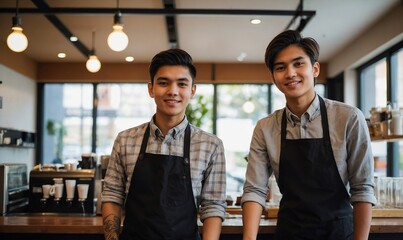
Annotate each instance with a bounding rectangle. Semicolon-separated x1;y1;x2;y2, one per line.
120;125;199;240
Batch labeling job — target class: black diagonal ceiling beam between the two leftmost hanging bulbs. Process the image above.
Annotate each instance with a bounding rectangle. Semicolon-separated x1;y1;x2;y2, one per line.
32;0;91;58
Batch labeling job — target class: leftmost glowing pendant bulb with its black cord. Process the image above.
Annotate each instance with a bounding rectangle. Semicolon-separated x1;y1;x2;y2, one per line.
7;0;28;52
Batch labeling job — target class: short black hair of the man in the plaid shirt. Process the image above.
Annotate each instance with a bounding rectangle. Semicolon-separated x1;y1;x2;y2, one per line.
149;48;196;84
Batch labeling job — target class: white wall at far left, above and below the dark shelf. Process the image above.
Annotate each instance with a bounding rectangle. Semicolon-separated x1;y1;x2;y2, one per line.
0;64;37;170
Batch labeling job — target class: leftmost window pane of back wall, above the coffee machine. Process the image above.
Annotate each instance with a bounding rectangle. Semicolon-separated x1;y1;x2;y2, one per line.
42;84;93;164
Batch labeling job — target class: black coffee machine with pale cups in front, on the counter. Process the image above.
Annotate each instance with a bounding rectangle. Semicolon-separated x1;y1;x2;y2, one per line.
28;169;96;215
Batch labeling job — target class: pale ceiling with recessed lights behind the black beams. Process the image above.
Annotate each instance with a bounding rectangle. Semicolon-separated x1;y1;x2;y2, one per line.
0;0;402;63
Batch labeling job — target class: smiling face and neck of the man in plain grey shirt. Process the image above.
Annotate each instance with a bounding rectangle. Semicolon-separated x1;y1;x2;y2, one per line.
273;44;319;104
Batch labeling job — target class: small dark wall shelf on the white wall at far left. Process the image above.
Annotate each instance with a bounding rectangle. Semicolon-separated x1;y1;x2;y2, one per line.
0;127;36;148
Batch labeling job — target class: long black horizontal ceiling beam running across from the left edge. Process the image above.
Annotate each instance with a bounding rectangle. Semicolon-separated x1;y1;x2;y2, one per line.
0;7;316;17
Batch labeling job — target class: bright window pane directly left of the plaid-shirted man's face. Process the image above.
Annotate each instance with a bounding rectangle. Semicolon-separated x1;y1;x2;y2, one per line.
96;83;155;155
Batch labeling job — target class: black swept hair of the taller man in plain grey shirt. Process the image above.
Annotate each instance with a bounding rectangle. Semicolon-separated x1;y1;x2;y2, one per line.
264;30;319;73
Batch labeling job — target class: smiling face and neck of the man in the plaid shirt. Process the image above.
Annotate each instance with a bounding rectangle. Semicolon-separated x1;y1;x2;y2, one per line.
148;65;196;127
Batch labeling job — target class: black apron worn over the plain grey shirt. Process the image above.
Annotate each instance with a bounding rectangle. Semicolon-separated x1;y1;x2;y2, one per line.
275;96;353;240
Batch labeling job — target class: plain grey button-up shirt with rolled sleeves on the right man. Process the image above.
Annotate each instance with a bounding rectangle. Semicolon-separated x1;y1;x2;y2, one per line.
242;96;376;208
